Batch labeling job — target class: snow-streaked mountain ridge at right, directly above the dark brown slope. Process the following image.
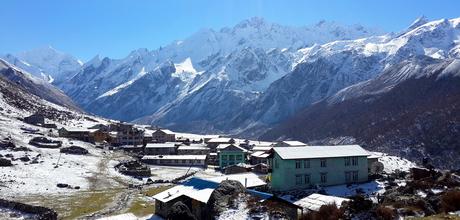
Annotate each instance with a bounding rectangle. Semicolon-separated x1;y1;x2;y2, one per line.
226;19;460;133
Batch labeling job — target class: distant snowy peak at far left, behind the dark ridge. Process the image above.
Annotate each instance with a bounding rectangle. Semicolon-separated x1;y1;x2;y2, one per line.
2;46;83;84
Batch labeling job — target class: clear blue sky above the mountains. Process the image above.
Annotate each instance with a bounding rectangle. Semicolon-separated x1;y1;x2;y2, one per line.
0;0;460;60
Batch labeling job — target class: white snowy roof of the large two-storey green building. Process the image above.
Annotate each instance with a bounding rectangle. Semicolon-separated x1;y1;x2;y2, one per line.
273;145;370;159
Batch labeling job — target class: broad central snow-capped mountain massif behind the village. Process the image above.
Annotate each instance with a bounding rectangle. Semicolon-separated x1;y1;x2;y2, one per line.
59;18;380;124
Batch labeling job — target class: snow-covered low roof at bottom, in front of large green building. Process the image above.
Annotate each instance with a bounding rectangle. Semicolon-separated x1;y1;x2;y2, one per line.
294;193;349;211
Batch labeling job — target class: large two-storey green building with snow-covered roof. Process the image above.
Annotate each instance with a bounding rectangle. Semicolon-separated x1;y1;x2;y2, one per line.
270;145;370;191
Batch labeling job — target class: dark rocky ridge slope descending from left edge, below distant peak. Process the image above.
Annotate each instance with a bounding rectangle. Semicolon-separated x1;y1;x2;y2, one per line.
0;59;80;111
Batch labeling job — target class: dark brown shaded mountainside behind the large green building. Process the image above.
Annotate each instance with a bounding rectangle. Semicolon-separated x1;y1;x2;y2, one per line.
262;56;460;169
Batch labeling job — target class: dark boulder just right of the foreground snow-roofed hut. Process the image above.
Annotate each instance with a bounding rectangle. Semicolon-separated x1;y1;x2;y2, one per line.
207;180;245;216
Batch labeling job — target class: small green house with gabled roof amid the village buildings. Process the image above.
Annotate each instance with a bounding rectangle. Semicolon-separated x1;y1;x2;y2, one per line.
217;144;247;169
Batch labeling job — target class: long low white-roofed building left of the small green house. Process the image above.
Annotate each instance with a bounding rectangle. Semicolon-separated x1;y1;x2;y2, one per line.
142;155;207;167
